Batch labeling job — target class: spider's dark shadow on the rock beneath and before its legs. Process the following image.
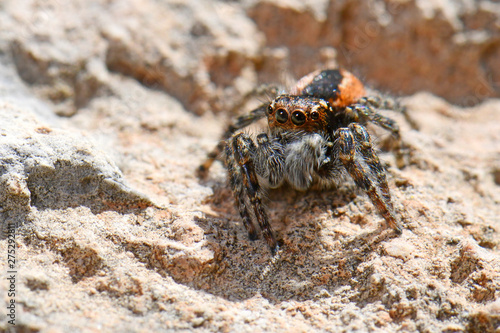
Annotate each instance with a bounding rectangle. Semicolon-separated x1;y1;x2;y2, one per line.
190;182;392;302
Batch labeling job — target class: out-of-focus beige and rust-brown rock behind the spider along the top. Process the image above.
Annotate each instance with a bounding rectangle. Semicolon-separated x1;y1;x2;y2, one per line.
0;0;500;115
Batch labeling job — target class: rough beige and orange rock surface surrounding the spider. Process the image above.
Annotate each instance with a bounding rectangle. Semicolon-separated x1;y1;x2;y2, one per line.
0;0;500;332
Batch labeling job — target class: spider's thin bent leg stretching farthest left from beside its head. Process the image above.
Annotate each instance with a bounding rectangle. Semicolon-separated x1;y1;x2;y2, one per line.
196;104;267;178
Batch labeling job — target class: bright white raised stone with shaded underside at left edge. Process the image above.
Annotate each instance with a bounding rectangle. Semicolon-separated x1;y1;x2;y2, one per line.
0;61;153;229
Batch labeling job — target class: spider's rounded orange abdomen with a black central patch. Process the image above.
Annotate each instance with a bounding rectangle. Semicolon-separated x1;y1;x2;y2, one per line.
290;69;365;109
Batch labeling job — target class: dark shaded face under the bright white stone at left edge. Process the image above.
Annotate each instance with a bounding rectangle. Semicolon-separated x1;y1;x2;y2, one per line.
0;161;157;240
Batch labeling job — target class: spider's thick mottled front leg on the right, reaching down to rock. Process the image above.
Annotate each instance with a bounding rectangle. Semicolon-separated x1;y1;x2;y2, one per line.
334;123;402;233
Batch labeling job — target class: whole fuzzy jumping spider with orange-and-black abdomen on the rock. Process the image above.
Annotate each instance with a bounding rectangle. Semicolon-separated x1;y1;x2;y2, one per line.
198;69;401;254
